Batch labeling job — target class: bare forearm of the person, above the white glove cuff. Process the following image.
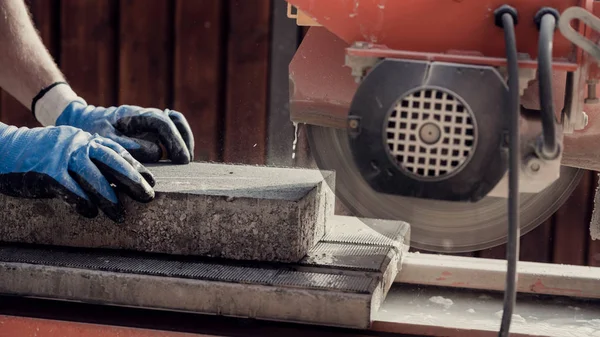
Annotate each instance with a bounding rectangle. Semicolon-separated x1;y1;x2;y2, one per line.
0;0;64;108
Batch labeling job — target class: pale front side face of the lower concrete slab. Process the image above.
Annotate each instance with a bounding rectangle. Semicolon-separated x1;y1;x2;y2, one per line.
0;263;372;329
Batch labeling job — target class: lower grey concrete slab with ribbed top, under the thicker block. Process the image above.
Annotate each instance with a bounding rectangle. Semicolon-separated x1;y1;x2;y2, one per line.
0;217;410;329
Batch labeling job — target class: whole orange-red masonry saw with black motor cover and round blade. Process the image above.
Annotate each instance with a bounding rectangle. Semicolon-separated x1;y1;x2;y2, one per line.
287;0;600;253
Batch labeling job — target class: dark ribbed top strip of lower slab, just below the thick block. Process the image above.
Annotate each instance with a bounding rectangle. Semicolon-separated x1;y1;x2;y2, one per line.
0;246;376;293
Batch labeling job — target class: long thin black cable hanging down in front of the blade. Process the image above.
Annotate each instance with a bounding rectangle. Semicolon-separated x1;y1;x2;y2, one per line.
496;6;521;337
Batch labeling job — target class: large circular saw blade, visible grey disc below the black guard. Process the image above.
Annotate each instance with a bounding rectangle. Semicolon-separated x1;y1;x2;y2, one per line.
307;125;583;253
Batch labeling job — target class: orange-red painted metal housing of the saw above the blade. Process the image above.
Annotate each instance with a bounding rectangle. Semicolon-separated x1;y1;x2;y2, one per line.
287;0;600;170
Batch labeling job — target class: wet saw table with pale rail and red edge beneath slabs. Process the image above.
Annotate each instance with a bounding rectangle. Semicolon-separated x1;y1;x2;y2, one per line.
0;253;600;337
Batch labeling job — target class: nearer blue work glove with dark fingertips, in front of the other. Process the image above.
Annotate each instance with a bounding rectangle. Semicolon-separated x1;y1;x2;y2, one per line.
0;123;154;223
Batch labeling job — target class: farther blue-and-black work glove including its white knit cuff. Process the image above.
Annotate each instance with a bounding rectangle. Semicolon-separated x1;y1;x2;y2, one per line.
32;83;194;164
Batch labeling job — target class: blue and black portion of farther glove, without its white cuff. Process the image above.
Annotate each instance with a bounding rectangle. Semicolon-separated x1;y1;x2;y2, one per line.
56;101;194;164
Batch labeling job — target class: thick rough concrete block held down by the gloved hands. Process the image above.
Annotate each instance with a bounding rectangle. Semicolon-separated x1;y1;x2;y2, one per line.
0;163;335;262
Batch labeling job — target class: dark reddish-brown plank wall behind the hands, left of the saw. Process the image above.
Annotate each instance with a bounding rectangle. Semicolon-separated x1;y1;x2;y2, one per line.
0;0;271;164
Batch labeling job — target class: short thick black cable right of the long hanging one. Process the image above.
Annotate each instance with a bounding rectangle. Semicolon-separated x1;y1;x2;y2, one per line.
535;8;558;159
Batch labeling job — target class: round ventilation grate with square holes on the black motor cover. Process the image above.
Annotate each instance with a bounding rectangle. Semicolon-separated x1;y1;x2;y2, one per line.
386;88;476;180
